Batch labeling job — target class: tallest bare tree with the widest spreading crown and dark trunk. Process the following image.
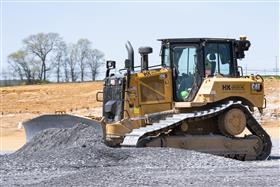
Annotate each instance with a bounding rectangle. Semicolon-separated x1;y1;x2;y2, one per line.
23;33;61;80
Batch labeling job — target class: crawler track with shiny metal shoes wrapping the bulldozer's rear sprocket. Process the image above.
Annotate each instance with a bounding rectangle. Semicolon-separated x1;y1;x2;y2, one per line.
122;101;272;160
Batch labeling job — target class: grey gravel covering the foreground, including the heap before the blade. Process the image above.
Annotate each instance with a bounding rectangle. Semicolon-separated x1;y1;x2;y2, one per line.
0;124;280;186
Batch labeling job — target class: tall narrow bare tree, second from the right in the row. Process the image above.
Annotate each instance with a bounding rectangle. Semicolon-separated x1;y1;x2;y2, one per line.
76;39;91;81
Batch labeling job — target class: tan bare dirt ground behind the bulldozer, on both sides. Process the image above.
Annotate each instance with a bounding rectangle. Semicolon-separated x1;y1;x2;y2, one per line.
0;79;280;151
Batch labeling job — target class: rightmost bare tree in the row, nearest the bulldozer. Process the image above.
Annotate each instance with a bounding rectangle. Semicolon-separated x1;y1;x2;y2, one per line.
87;49;104;81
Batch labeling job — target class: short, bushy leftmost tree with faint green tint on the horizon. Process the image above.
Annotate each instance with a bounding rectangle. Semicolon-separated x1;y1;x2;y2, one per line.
8;50;39;84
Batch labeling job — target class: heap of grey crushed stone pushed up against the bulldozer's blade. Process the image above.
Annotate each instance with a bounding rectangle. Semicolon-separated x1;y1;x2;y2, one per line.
15;124;104;155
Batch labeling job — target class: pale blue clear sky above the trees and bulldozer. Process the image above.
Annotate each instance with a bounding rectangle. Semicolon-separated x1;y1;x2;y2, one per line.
1;0;279;79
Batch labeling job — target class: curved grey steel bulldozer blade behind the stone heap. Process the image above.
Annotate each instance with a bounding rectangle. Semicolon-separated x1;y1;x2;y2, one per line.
22;114;102;142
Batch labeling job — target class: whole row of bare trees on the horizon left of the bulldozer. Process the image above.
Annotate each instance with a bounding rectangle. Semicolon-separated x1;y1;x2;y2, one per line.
8;33;104;84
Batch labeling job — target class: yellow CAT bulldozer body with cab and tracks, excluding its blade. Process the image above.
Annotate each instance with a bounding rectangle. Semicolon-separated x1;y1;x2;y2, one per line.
23;36;272;160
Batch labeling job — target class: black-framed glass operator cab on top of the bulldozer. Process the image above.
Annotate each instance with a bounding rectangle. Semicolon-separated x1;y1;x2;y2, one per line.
160;37;250;102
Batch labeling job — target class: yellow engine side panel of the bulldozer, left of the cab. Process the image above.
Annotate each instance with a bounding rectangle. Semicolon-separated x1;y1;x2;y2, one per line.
124;69;173;127
